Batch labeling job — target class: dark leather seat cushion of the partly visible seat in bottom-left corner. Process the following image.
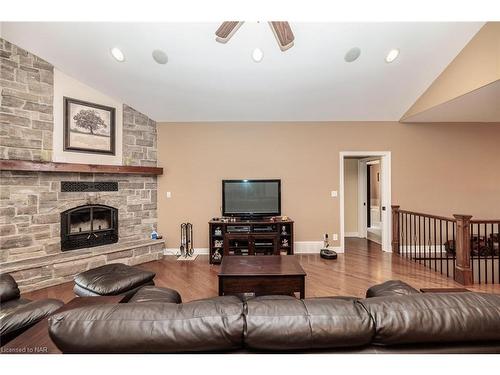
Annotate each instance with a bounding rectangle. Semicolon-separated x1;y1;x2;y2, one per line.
0;299;63;345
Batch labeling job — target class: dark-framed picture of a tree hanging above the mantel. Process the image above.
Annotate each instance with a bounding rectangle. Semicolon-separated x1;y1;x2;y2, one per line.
64;97;116;155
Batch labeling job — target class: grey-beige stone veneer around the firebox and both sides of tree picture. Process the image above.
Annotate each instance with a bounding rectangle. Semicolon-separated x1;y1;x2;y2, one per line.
0;39;164;290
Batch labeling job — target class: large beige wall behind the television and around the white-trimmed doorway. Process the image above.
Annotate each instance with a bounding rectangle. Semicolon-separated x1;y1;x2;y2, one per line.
158;122;500;248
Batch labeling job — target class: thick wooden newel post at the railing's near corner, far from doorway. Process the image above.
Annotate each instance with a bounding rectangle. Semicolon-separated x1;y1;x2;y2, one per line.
453;215;474;285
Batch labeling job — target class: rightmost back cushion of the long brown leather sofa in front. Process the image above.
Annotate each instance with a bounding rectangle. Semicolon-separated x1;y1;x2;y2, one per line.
359;293;500;345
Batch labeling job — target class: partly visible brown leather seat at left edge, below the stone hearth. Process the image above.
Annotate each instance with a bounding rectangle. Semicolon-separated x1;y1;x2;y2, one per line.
0;274;63;346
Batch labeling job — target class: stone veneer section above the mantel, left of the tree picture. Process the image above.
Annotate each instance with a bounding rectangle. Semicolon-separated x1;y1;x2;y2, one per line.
0;38;54;161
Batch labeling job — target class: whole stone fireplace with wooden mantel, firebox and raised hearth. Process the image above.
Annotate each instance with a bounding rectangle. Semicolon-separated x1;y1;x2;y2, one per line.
0;38;165;292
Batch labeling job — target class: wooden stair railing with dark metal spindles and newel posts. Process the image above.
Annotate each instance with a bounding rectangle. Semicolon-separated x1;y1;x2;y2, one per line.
392;205;500;285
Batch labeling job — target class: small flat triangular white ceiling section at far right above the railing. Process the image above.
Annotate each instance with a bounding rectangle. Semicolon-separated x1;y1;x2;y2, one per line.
403;80;500;123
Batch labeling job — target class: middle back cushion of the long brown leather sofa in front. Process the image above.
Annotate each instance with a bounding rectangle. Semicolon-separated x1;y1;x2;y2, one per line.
245;298;374;351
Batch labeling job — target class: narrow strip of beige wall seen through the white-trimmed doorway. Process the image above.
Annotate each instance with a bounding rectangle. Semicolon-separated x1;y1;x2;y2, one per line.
344;159;358;233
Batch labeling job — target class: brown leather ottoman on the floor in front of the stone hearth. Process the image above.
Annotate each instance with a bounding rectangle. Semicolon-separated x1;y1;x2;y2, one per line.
73;263;155;302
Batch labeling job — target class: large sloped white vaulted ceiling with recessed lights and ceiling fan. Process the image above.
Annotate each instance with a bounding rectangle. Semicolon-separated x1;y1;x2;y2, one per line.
2;22;483;121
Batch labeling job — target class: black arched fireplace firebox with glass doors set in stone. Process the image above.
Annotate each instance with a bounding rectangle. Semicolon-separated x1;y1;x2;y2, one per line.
61;204;118;251
